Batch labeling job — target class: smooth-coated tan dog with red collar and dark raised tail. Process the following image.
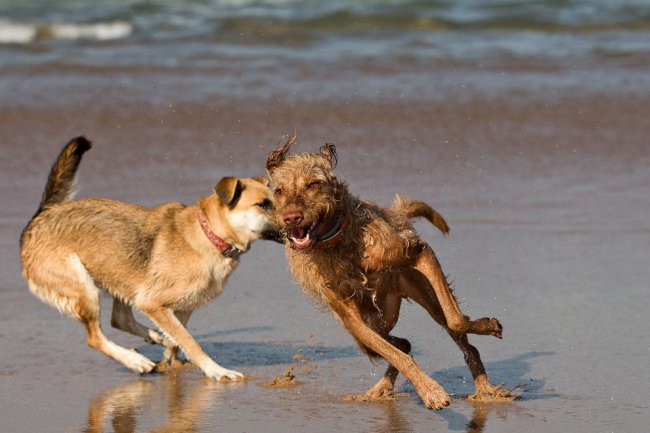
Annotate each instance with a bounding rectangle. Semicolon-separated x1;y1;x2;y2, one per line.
21;137;273;380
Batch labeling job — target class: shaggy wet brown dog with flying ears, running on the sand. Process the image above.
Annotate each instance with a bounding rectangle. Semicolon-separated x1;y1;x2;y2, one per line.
266;136;510;409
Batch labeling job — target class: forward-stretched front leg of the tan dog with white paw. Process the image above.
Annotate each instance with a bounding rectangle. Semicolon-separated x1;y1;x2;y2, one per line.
143;308;244;380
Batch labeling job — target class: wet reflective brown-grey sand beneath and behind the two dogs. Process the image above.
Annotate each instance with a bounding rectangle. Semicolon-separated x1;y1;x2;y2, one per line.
0;82;650;433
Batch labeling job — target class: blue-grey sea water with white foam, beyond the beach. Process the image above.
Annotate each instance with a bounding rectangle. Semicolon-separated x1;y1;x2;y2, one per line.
0;0;650;99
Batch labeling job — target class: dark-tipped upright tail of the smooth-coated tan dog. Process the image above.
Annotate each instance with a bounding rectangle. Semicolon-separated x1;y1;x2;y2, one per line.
34;136;91;217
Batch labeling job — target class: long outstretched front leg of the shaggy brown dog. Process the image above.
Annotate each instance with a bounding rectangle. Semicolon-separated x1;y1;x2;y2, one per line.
324;290;451;409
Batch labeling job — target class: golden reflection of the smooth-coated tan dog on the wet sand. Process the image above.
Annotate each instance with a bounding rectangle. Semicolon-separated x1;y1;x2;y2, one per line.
82;374;219;433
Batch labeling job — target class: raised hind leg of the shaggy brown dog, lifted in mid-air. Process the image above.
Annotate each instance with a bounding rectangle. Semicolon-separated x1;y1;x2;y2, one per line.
415;245;503;338
